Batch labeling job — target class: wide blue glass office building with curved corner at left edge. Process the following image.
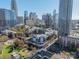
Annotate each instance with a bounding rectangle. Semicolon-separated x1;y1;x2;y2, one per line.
0;9;16;30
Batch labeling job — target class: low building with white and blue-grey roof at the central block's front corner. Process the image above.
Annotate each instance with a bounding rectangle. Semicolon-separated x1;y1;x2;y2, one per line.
26;34;46;48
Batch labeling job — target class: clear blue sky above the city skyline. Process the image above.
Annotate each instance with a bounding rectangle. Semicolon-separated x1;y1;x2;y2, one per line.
0;0;79;19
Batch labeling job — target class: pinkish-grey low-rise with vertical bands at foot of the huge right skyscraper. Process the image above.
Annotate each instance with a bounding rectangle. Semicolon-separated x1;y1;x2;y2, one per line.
59;36;79;48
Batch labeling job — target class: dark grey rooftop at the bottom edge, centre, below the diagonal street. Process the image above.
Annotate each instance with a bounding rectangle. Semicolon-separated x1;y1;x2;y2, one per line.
30;49;52;59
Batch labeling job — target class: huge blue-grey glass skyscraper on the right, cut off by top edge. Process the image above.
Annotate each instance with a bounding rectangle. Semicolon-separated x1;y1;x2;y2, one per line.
58;0;73;36
